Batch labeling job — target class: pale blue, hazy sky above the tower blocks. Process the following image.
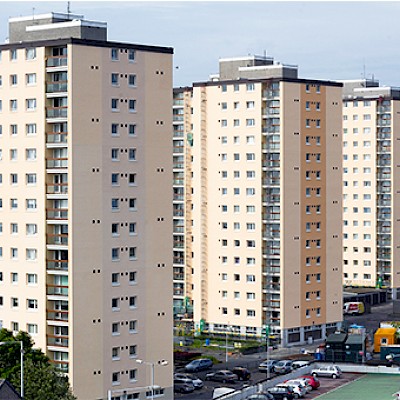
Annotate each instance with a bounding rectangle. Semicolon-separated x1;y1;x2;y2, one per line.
0;0;400;87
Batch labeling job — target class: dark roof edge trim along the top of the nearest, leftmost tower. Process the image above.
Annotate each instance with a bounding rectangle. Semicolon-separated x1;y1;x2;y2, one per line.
0;38;174;54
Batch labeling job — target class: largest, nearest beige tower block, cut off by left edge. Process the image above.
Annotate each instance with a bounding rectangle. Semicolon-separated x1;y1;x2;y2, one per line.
0;13;173;400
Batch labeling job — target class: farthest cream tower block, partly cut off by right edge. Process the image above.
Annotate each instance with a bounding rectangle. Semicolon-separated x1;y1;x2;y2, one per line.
343;79;400;298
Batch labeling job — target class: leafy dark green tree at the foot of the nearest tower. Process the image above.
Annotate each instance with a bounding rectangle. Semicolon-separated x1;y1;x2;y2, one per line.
0;329;76;400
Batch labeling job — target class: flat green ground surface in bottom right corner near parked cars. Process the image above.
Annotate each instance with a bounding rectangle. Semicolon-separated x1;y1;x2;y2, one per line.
317;374;400;400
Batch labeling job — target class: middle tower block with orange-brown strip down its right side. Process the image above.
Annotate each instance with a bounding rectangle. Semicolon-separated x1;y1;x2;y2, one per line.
174;57;342;345
